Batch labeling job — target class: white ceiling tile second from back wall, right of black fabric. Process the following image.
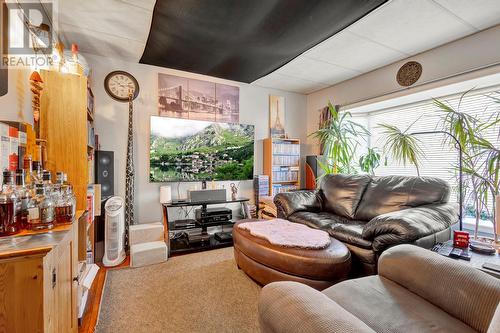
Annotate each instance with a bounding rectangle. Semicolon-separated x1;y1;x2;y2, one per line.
277;55;360;84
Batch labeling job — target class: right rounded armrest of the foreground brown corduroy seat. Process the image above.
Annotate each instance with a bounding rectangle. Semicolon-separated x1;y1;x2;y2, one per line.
378;244;500;332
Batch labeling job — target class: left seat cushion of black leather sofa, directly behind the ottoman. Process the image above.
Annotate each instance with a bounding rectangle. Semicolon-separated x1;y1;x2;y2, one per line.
288;212;372;249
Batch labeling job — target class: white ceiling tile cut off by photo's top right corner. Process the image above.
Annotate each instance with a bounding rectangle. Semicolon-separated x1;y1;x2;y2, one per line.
434;0;500;30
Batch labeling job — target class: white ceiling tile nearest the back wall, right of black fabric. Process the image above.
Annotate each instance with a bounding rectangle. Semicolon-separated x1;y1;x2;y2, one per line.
252;72;328;94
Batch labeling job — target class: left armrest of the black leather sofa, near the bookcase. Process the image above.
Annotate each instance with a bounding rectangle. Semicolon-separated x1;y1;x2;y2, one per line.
274;190;322;219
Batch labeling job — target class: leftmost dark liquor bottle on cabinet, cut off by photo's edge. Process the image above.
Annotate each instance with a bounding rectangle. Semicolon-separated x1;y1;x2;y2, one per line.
0;171;21;236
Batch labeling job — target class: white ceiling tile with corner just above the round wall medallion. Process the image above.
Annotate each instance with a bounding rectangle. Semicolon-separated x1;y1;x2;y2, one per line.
305;30;406;72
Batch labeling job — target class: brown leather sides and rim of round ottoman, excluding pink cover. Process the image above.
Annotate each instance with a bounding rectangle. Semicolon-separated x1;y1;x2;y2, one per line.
233;220;351;290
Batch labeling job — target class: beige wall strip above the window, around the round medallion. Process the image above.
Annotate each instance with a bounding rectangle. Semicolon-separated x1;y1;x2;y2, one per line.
307;25;500;153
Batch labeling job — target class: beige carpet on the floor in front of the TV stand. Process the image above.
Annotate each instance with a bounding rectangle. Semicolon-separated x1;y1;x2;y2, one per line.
96;247;260;333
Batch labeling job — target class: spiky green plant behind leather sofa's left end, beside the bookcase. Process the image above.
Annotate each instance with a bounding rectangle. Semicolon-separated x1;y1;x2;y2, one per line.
310;102;370;174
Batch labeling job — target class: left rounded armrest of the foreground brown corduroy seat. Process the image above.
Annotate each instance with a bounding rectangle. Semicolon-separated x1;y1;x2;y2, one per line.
258;282;375;333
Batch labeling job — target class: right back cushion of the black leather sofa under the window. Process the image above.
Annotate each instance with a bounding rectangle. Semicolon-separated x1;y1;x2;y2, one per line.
355;176;450;221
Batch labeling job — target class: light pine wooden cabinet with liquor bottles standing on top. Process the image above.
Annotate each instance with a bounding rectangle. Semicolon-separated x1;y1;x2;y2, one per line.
0;222;78;333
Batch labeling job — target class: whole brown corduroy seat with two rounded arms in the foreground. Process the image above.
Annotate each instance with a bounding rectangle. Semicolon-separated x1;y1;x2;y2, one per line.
259;244;500;333
